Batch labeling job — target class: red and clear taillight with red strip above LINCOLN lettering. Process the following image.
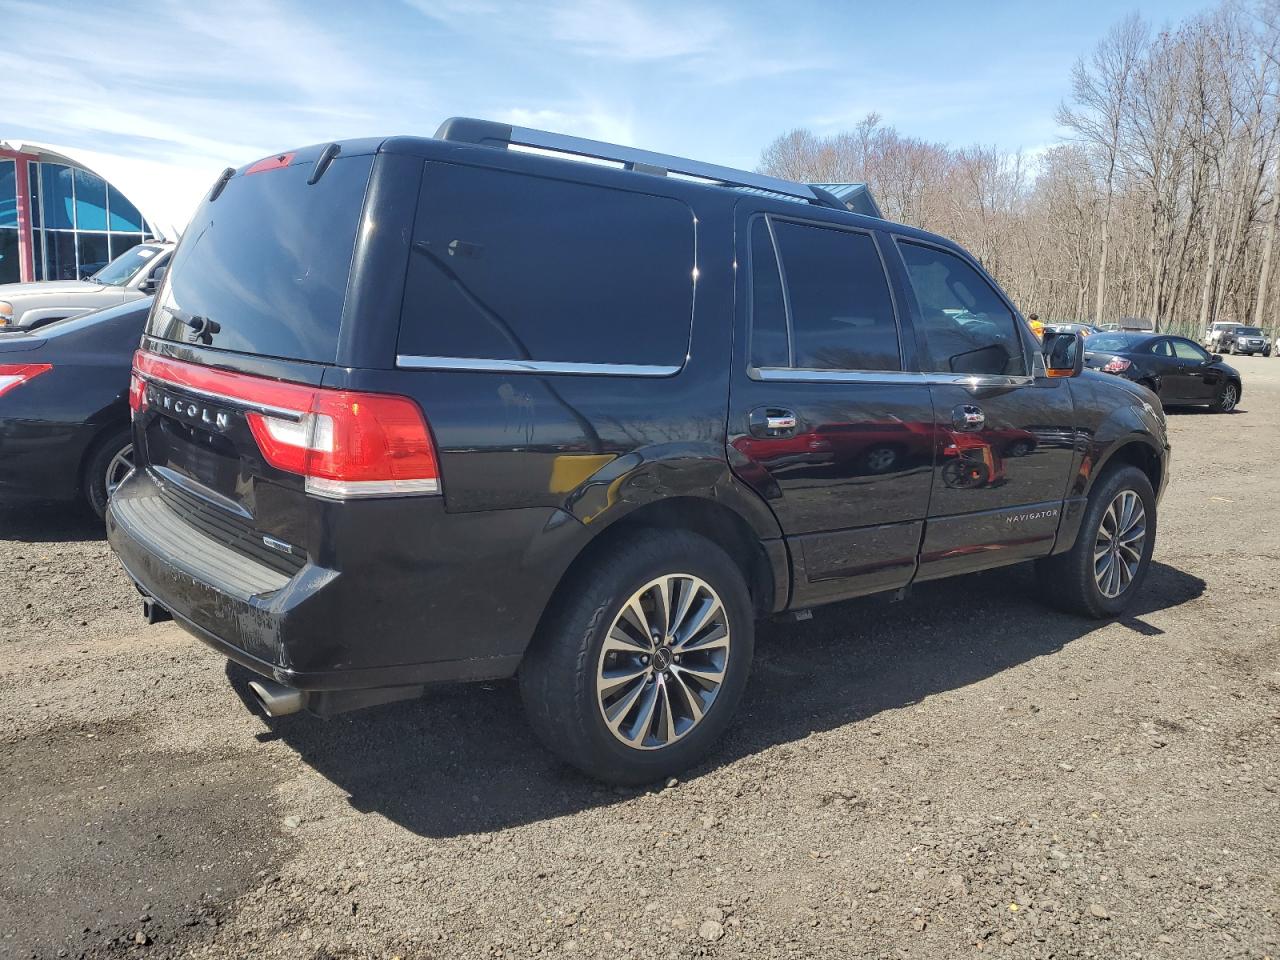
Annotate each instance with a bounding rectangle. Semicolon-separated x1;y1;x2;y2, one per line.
129;351;440;499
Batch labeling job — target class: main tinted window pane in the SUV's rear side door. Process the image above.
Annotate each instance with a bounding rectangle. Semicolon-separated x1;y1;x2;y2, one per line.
753;220;901;370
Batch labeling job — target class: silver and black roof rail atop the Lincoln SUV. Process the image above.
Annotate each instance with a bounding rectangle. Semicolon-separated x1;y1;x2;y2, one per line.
435;116;849;210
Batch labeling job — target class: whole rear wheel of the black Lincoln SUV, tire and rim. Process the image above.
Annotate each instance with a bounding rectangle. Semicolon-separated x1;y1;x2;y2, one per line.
520;530;755;785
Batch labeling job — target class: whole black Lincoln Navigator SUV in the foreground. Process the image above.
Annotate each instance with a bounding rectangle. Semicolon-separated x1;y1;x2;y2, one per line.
108;120;1169;782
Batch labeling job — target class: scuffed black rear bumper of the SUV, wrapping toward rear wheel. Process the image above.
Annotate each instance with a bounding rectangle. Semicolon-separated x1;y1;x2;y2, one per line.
106;470;578;691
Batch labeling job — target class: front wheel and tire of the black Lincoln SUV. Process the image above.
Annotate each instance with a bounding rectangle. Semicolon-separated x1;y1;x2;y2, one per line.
1036;466;1156;620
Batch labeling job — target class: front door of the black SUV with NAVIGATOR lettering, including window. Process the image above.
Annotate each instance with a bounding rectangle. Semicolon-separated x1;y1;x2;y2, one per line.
895;237;1075;580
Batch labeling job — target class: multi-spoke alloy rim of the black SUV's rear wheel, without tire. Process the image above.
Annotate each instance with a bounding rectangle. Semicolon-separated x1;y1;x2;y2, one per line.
595;573;731;750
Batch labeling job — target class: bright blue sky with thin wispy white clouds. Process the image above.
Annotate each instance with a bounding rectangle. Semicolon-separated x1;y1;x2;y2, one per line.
0;0;1206;190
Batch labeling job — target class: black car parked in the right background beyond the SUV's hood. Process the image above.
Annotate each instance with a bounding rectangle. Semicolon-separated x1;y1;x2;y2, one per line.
1084;333;1243;413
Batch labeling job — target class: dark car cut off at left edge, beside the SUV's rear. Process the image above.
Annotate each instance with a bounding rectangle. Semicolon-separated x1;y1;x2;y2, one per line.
0;297;151;516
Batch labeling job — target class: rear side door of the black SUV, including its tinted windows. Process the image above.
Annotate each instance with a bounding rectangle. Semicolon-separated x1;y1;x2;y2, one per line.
728;204;934;604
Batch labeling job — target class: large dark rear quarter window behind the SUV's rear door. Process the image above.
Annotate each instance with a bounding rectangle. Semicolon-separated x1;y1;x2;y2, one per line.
399;163;694;366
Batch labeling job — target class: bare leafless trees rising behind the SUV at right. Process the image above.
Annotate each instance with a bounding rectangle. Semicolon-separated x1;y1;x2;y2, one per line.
760;0;1280;335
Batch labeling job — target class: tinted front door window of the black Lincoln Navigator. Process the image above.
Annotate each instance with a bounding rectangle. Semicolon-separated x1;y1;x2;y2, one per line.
899;241;1027;376
